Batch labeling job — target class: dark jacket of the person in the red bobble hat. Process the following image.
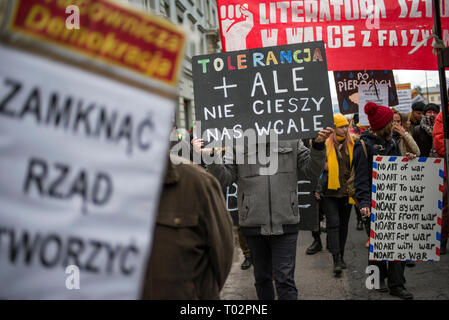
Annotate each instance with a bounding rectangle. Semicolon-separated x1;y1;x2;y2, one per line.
353;131;401;208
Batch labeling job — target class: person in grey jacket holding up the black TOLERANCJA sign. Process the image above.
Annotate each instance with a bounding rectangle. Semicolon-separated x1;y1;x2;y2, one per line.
208;128;333;300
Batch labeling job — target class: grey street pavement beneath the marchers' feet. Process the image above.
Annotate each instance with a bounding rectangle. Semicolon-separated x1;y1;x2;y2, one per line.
221;210;449;300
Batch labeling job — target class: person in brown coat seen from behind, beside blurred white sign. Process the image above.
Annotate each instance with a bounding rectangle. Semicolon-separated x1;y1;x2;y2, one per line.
142;156;234;300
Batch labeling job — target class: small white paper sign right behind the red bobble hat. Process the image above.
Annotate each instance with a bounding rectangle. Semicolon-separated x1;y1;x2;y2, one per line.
358;84;388;126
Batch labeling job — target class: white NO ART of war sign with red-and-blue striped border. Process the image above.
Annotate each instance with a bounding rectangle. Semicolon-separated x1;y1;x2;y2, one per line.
369;156;444;261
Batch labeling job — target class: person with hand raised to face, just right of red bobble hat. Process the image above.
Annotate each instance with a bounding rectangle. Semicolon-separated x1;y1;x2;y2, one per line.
393;109;420;156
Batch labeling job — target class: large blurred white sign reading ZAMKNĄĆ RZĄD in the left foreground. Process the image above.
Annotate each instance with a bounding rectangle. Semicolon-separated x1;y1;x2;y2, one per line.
0;46;174;299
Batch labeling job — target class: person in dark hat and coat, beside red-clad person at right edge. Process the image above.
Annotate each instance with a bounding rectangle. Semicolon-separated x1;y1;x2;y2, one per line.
413;103;440;157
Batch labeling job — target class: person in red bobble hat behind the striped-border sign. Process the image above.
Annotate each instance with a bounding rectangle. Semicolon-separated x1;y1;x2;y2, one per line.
354;102;415;299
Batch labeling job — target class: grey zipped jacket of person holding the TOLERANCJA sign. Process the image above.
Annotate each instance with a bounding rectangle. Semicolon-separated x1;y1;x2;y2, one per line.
208;140;326;235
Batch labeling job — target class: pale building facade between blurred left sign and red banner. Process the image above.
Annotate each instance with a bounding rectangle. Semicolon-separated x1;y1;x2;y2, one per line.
128;0;221;129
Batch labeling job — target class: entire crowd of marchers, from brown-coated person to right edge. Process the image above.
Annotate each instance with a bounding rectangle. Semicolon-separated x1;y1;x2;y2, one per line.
143;89;449;300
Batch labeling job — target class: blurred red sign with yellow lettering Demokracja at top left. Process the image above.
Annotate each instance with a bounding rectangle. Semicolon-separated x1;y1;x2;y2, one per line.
3;0;185;86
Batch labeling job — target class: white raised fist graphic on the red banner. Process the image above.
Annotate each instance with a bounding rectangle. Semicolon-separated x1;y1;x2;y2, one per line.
220;3;254;51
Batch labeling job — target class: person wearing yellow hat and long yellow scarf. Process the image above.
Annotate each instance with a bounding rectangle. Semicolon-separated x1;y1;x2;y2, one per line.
322;113;354;276
